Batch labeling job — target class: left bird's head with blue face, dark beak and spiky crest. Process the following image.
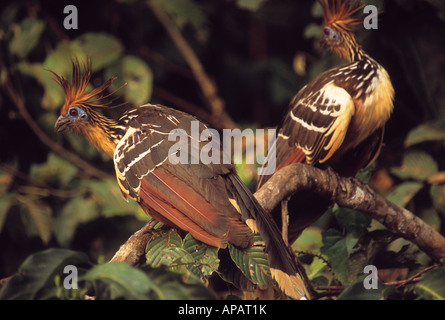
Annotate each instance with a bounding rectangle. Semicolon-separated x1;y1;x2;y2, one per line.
52;58;115;133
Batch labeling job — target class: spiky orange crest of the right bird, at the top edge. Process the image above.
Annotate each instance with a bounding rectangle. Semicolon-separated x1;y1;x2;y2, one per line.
318;0;364;31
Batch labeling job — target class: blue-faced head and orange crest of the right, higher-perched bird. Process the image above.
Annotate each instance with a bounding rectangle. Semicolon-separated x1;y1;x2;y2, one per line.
318;0;363;60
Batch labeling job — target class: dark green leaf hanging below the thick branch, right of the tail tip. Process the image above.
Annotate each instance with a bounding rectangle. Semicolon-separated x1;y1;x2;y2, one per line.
320;229;349;282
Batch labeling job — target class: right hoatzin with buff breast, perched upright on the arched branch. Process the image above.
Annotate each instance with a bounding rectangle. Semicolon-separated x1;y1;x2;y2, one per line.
258;0;394;243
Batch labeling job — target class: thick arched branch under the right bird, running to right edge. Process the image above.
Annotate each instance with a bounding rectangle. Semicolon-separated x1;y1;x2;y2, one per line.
255;163;445;260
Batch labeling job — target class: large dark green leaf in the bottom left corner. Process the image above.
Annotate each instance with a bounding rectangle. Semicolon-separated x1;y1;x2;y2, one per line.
0;249;90;300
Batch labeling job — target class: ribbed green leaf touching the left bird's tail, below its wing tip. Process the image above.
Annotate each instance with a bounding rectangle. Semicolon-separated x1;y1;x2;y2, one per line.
229;236;273;285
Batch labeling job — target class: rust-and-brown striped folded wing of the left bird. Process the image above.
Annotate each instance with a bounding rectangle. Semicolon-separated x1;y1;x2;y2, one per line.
114;106;252;247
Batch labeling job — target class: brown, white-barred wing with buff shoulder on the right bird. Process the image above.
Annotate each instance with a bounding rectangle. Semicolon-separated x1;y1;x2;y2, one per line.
258;81;355;186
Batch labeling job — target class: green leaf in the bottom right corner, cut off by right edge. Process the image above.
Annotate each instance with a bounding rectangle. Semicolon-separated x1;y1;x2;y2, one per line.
414;267;445;300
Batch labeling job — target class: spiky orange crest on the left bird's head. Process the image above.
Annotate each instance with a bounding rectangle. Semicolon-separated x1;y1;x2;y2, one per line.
51;57;120;114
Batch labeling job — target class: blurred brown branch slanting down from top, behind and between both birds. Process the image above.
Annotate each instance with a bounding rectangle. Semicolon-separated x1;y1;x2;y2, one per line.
147;1;238;129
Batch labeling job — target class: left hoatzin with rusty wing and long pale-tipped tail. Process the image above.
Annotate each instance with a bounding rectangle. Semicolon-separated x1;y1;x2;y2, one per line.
53;59;309;299
